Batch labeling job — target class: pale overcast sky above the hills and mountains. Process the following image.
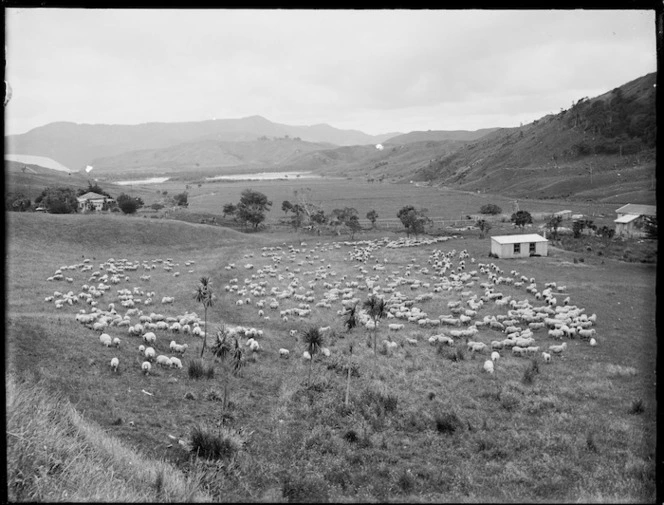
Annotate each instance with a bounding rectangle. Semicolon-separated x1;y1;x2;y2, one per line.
5;8;656;134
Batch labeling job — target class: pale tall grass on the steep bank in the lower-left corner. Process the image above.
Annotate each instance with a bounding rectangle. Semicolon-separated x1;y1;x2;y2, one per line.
5;375;210;502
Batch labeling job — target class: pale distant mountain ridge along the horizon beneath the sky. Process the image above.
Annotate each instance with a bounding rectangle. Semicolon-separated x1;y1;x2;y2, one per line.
5;116;399;171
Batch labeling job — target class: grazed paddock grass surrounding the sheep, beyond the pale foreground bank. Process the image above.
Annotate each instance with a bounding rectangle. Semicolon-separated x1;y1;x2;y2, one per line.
6;192;657;502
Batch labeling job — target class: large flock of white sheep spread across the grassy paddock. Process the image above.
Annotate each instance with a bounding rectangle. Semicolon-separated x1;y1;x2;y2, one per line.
45;237;597;382
